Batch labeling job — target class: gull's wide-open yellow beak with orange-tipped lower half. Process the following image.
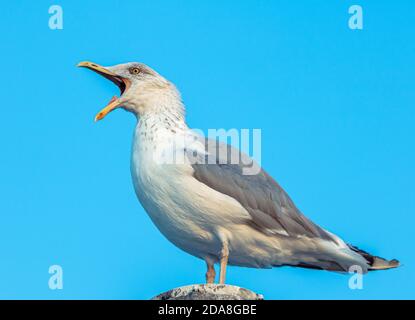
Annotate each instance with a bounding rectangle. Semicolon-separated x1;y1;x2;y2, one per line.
78;61;130;121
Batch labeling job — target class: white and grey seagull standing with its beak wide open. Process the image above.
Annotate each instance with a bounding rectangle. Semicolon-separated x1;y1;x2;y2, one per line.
78;61;399;284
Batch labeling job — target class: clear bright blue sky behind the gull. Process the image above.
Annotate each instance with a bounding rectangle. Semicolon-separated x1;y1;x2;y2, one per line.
0;0;415;299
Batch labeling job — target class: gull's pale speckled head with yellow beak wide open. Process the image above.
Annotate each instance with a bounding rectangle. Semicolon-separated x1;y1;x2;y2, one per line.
78;61;183;121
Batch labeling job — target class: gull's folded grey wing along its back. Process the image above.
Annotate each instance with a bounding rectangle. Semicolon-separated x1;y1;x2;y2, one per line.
188;137;336;242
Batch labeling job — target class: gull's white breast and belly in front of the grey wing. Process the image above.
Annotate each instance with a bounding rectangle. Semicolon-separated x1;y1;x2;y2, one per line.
131;126;254;258
